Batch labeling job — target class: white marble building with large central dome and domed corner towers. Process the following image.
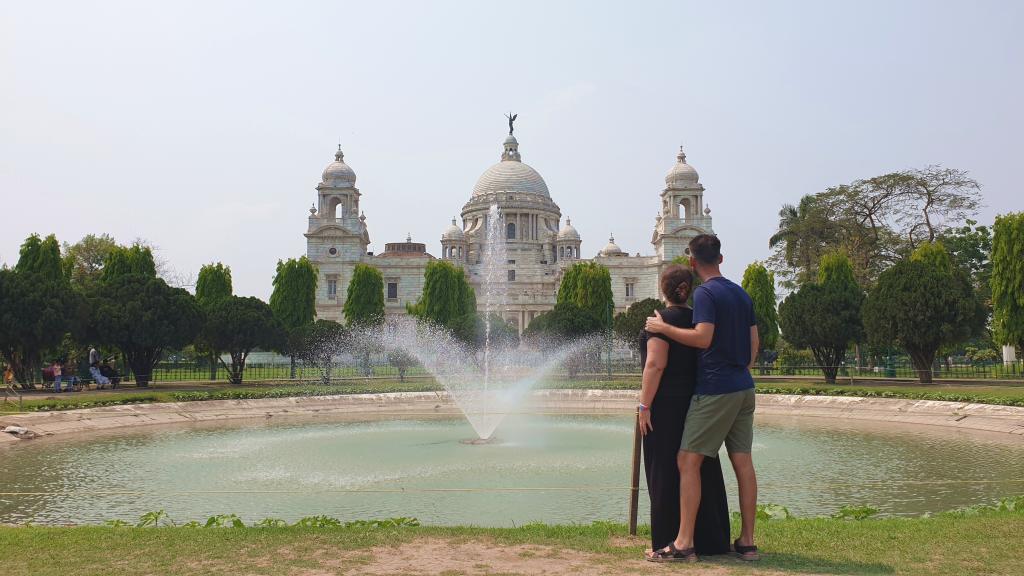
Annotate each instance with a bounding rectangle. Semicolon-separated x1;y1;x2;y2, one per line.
305;127;713;331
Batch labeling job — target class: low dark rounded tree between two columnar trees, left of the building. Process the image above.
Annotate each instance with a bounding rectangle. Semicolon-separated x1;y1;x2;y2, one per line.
203;296;285;384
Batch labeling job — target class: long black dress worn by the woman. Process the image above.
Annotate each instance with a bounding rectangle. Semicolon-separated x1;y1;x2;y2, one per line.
640;306;729;554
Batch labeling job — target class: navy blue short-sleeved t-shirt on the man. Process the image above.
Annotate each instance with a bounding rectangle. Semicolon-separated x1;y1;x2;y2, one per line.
693;276;757;395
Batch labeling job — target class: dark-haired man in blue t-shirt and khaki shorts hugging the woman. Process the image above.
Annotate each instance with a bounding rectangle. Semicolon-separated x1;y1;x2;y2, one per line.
646;234;760;562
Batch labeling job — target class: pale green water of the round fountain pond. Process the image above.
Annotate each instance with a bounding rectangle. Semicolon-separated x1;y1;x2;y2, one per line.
0;416;1024;526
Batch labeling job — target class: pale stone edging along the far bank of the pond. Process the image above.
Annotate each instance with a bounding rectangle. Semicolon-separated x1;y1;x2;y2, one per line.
0;389;1024;445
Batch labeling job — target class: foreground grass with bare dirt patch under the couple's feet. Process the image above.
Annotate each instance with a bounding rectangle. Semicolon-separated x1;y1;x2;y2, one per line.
0;511;1024;576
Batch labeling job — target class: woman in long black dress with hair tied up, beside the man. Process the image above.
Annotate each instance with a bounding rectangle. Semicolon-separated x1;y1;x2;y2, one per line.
638;264;729;562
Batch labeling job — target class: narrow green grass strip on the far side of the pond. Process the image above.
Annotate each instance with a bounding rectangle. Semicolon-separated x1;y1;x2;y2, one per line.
0;376;1024;413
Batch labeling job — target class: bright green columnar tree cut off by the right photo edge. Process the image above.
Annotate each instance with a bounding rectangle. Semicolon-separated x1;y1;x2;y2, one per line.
991;212;1024;353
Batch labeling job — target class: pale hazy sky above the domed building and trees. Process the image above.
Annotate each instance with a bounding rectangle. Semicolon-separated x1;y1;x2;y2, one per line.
0;0;1024;298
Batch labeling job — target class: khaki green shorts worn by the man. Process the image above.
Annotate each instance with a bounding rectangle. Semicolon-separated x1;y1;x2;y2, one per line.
679;388;755;458
